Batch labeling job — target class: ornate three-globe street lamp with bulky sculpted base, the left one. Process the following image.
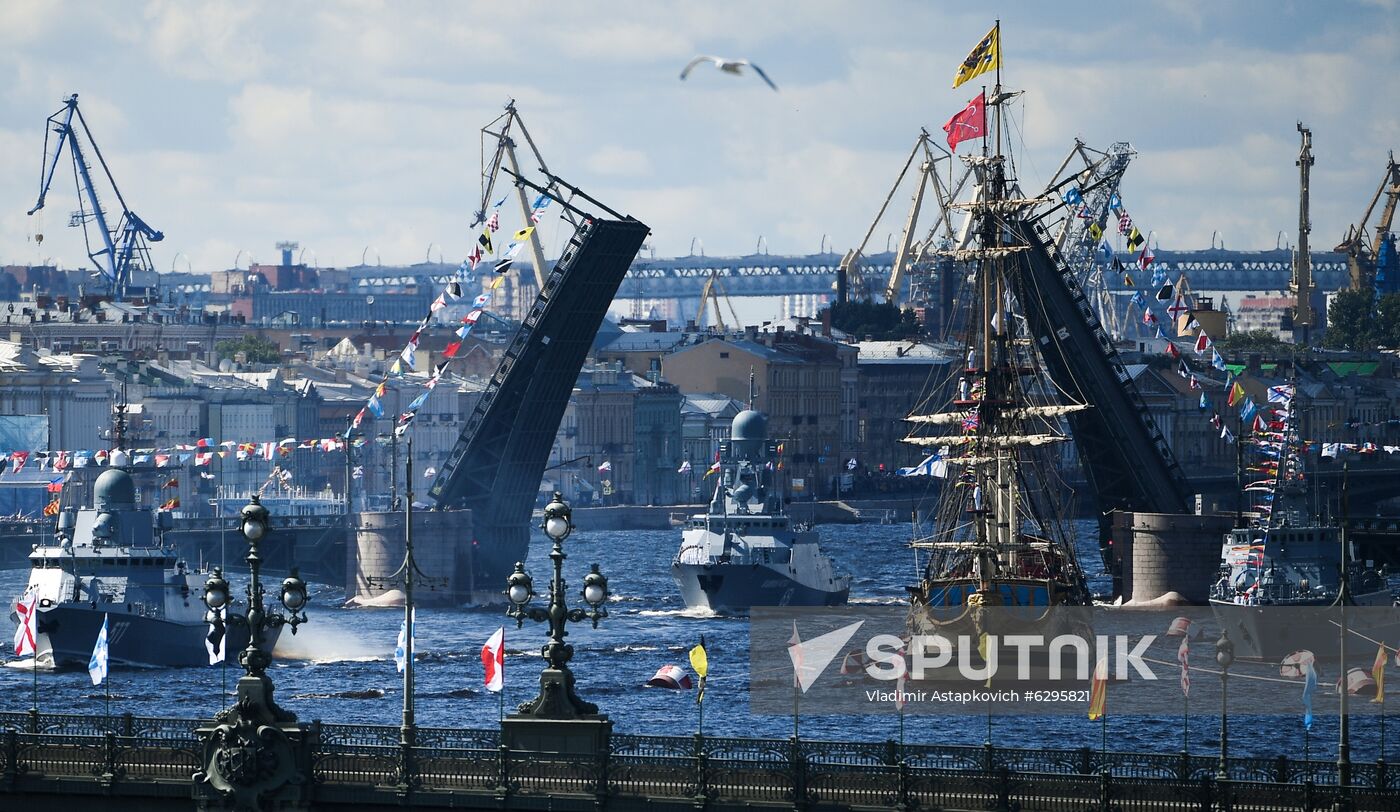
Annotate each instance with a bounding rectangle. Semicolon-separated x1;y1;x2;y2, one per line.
195;494;307;808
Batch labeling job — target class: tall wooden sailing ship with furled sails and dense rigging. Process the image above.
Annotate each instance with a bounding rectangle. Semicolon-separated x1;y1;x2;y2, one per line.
906;77;1091;638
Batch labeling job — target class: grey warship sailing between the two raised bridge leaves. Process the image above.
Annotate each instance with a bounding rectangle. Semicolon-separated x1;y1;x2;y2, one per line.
671;409;851;615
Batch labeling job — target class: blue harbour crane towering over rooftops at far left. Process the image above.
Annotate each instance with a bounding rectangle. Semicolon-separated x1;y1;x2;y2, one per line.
29;94;165;300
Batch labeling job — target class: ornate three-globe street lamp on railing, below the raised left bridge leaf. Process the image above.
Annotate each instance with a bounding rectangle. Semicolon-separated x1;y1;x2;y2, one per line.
505;490;608;720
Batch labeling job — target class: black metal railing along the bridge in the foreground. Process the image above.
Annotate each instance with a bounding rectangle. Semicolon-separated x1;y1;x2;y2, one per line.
0;713;1400;811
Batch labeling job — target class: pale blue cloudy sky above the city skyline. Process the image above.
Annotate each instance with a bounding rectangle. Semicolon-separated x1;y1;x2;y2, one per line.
0;0;1400;272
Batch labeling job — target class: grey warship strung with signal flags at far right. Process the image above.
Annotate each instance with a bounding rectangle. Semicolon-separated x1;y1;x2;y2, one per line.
1210;384;1400;661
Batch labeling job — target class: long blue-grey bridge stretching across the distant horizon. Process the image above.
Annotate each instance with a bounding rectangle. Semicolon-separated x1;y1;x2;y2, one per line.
161;248;1348;300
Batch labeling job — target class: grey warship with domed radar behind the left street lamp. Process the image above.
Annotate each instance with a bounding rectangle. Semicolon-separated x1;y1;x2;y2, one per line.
12;469;280;668
